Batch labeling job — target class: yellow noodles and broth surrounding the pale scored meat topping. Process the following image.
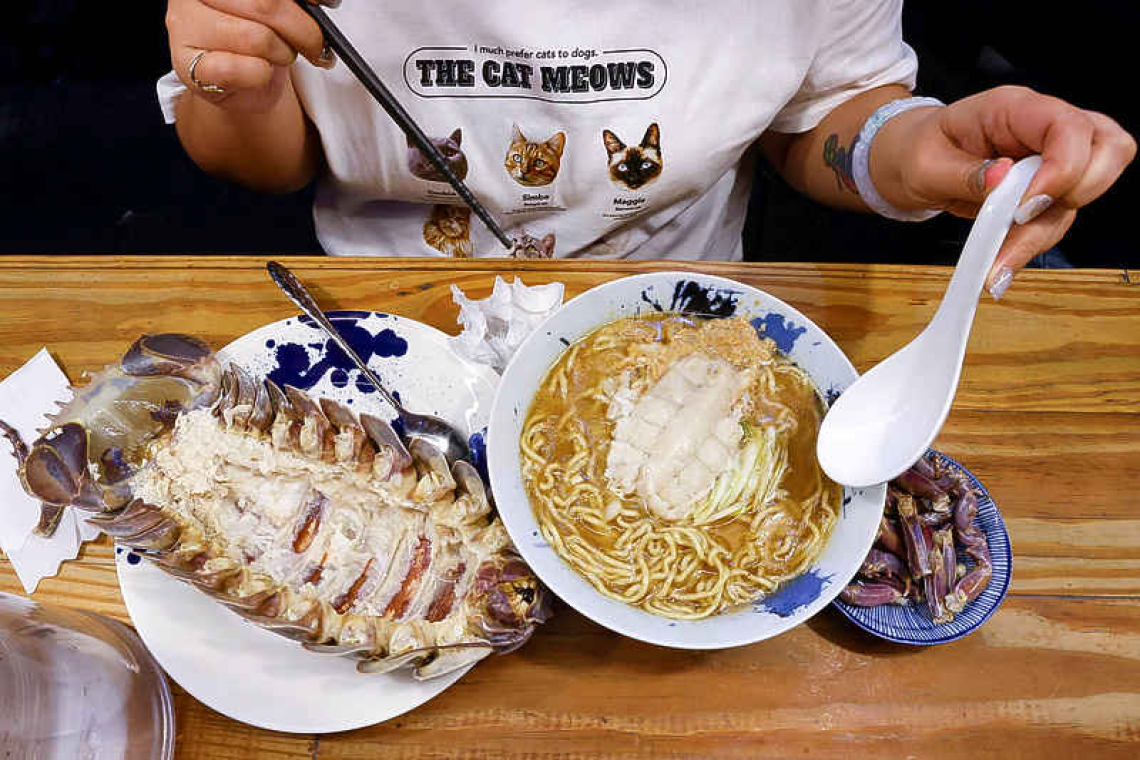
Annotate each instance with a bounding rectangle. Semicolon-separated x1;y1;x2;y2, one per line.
520;316;841;620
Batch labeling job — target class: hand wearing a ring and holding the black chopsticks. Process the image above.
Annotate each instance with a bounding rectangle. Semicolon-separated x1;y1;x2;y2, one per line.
166;0;340;112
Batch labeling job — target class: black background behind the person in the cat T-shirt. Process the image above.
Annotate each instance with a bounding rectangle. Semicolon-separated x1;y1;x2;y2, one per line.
0;0;1140;268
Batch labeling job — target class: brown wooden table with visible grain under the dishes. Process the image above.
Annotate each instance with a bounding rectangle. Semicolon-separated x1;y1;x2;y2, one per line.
0;258;1140;760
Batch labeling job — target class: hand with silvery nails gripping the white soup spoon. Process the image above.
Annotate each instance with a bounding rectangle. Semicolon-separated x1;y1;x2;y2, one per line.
888;87;1137;297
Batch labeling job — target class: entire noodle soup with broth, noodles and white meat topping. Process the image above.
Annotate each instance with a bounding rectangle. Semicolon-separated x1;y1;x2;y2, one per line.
520;313;842;620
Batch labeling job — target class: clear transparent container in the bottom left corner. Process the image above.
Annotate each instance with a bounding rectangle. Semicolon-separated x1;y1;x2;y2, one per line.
0;594;174;760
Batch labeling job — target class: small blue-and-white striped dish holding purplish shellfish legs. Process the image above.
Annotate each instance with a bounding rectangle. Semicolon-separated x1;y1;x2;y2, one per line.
832;452;1012;646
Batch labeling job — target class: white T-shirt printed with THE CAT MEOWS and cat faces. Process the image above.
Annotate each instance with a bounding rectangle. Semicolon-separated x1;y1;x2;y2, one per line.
160;0;917;260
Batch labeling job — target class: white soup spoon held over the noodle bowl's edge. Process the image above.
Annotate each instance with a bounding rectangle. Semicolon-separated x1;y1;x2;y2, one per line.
816;156;1041;488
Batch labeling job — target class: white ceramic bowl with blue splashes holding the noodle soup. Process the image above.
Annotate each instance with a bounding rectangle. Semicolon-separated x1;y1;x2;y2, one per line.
487;272;886;649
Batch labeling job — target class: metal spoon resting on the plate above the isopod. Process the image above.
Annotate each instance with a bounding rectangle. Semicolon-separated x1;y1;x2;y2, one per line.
266;261;471;465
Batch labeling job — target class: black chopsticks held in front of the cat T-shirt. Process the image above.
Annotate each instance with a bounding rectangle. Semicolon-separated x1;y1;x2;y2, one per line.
296;0;514;251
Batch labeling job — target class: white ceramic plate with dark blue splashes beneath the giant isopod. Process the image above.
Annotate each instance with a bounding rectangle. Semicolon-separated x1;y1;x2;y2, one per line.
116;311;497;734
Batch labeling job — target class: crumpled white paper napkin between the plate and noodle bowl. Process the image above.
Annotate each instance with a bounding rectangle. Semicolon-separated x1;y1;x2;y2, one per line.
451;277;565;374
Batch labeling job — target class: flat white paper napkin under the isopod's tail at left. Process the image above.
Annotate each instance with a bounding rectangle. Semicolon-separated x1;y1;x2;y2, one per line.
0;349;99;594
